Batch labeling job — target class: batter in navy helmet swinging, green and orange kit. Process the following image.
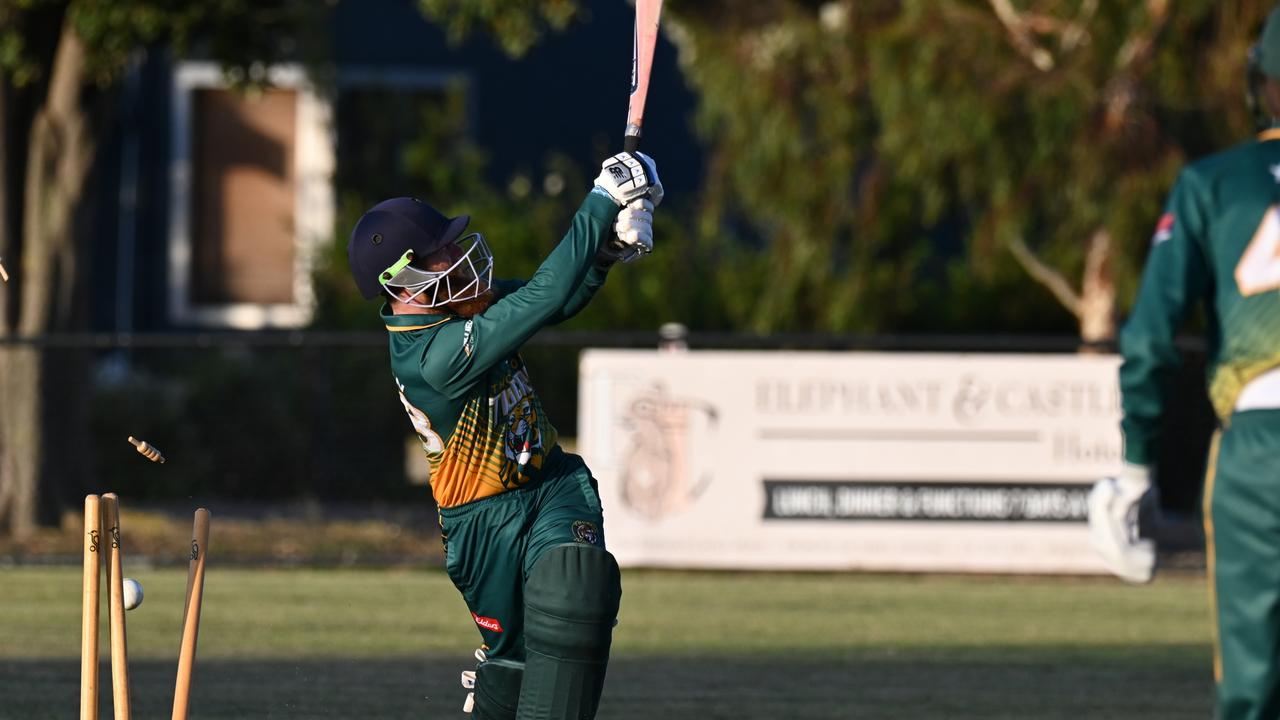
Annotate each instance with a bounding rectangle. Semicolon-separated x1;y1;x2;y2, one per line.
347;152;662;720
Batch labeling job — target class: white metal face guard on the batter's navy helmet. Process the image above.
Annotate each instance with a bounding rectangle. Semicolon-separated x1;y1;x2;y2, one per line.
378;232;493;307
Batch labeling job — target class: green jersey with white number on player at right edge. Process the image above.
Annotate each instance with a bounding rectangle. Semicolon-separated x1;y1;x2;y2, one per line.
1120;129;1280;465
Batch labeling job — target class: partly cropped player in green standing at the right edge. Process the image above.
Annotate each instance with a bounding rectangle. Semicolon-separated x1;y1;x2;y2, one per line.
1089;9;1280;720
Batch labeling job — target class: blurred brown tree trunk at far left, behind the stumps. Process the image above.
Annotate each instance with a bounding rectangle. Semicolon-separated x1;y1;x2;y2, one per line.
0;23;97;538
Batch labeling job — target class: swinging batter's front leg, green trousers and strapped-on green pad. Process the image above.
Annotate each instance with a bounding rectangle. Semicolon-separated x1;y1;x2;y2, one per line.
517;456;622;720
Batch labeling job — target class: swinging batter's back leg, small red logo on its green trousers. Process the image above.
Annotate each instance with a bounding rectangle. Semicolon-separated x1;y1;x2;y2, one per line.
440;491;532;720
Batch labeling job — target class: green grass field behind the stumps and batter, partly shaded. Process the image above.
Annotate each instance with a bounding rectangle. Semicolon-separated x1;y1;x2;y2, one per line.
0;565;1212;720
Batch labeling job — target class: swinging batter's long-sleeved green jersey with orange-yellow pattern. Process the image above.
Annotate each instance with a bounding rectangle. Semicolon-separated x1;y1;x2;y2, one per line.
381;193;618;509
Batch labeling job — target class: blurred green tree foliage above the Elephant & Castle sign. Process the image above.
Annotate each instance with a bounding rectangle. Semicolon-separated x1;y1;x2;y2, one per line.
421;0;1268;342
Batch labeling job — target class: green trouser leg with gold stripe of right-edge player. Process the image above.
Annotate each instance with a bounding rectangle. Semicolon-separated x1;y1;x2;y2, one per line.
1206;410;1280;720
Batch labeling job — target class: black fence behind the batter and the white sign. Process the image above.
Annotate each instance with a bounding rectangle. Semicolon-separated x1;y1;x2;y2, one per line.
0;332;1213;512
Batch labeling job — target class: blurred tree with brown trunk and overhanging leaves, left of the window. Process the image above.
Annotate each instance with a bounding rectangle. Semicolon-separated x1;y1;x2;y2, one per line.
0;0;317;537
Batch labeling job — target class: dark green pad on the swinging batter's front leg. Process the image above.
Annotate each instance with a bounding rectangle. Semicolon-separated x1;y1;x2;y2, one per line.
517;543;622;720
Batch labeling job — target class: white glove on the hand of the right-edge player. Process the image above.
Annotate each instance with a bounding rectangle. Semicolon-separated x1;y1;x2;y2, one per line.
1089;464;1156;583
